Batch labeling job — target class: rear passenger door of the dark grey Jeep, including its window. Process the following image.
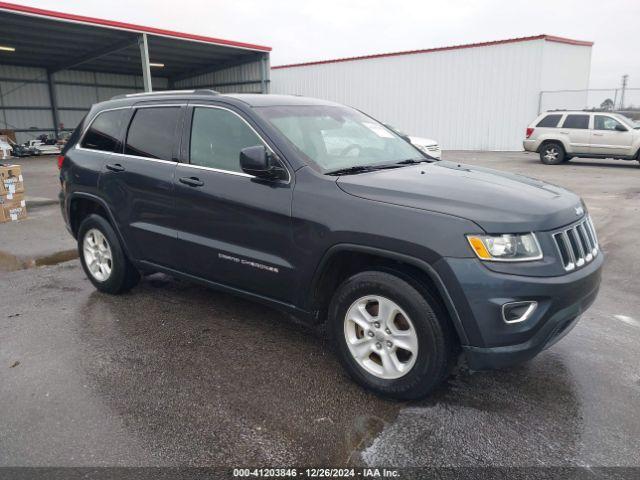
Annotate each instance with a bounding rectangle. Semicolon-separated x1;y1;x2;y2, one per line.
99;104;185;267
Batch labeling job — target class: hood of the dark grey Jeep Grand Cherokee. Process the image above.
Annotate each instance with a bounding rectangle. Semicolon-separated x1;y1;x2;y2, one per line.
337;161;582;233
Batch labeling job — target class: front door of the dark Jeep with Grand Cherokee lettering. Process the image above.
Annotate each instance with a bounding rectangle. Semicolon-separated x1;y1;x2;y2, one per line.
175;105;296;302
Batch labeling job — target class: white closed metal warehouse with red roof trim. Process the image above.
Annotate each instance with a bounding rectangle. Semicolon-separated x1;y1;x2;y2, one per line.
271;35;593;150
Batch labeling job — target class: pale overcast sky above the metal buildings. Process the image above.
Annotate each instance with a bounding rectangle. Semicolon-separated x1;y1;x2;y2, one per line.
8;0;640;88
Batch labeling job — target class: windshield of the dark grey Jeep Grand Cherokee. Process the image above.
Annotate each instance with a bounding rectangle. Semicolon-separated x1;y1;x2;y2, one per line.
256;105;426;173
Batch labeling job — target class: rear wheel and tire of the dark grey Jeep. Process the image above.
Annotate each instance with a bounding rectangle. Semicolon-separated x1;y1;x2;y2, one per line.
78;214;140;295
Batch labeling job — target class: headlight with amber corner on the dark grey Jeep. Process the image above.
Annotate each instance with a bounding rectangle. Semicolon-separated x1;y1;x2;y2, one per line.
467;233;542;262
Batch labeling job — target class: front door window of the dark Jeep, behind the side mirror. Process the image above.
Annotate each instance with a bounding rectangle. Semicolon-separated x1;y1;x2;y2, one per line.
190;107;263;172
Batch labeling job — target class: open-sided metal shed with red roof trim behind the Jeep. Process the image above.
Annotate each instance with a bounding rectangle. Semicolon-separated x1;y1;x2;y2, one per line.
0;2;271;143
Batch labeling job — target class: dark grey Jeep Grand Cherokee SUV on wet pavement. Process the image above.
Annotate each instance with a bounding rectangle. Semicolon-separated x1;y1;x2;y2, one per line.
59;91;603;399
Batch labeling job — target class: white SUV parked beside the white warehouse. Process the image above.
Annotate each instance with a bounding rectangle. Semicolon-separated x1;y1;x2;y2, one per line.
523;111;640;165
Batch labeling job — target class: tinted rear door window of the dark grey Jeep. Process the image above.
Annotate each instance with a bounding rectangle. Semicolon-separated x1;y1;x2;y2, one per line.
124;107;180;160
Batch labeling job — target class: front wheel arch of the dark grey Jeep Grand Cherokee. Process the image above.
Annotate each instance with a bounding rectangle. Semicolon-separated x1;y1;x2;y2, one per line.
308;244;468;345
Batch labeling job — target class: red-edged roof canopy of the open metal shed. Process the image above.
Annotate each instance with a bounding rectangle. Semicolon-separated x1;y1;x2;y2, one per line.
0;2;271;86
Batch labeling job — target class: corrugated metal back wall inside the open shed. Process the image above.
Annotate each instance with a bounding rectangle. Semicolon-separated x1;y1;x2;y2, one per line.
0;65;167;143
